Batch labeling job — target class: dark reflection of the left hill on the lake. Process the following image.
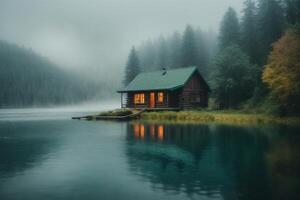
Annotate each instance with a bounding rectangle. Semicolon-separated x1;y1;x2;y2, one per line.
0;122;61;177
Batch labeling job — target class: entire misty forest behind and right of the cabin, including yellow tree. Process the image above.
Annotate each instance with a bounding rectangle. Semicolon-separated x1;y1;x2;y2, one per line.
124;0;300;114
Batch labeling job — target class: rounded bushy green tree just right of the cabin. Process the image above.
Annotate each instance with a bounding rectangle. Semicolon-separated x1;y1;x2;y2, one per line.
211;45;254;108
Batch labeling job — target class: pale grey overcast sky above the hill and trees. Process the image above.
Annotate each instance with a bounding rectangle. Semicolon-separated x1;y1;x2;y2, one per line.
0;0;243;82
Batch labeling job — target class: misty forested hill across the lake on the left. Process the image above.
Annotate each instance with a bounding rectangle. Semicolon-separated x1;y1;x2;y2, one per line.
0;41;99;107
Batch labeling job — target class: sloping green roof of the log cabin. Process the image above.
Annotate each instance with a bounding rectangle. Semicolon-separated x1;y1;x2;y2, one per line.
118;67;206;92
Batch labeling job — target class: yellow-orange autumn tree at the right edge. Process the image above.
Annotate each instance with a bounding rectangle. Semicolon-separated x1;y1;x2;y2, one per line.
262;29;300;111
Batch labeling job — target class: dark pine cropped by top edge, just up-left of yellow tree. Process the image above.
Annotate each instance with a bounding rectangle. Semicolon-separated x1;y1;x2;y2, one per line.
258;0;284;64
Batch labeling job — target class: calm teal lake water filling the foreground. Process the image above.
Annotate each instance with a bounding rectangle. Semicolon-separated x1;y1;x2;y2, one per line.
0;109;300;200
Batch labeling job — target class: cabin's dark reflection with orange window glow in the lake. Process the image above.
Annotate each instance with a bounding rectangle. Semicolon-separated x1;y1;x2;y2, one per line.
127;124;227;196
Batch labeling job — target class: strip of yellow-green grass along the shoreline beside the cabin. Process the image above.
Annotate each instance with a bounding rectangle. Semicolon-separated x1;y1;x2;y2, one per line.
141;111;300;124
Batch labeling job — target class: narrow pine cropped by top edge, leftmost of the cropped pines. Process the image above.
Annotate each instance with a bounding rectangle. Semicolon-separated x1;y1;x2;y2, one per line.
241;0;259;63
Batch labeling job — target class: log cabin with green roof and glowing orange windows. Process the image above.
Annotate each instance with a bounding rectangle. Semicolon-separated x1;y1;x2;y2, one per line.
118;67;209;108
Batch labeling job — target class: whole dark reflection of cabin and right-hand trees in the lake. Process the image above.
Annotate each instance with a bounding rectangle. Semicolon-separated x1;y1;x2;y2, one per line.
126;123;300;199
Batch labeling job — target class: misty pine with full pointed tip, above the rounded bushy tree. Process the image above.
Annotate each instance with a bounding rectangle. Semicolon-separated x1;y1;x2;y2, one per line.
219;7;240;50
